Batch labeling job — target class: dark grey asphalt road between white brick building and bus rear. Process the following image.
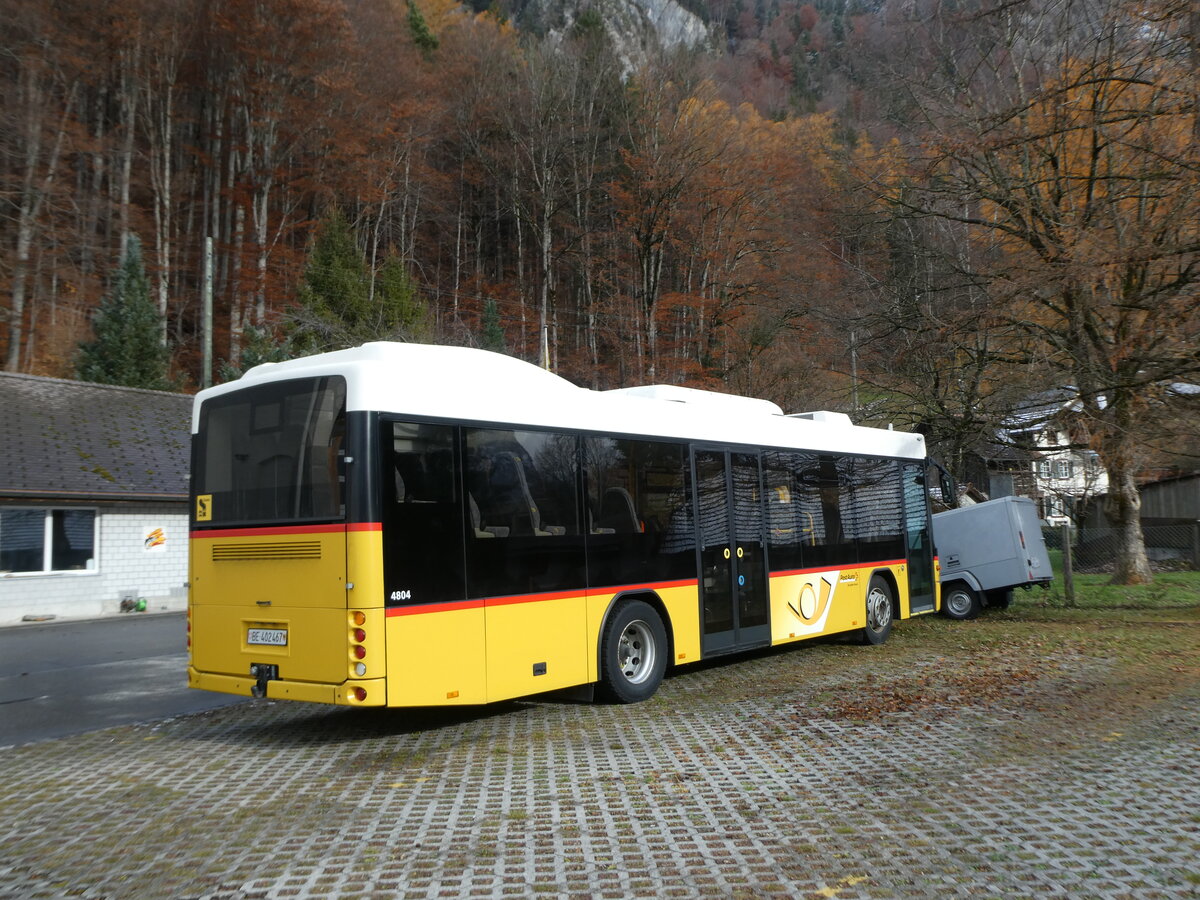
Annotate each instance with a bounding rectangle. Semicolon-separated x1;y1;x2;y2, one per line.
0;612;241;746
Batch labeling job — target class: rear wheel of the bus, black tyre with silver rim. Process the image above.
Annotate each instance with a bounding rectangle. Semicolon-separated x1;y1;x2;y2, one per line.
600;600;667;703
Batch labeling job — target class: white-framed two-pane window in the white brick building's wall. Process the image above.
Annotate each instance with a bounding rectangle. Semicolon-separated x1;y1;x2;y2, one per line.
0;509;96;574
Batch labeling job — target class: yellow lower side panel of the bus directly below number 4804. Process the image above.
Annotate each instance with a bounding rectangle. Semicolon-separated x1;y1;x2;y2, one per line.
388;605;487;707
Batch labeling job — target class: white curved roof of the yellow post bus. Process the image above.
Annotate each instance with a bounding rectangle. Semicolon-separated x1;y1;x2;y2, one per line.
192;342;925;460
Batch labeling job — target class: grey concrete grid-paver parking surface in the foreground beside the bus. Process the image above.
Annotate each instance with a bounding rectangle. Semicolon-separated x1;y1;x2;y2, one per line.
0;648;1200;900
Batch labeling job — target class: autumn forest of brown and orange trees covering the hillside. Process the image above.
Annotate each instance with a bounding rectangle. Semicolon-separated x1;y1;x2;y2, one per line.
0;0;1200;580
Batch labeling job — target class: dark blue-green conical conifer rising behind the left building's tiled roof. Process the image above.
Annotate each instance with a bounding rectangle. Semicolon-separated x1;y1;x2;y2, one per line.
76;234;178;390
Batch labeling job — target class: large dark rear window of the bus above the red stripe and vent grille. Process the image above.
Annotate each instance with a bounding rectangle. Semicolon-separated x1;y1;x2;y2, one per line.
193;377;346;527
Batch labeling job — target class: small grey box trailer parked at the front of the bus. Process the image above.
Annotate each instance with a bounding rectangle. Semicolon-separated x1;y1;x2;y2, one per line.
934;497;1054;619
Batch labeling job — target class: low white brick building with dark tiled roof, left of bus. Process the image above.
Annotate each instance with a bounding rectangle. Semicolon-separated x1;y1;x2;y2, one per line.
0;373;192;625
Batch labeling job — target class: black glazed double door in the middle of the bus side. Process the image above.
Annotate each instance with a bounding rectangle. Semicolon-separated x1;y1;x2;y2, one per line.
692;449;770;655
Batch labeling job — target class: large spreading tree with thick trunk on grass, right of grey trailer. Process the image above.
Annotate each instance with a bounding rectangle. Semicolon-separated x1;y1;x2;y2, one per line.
890;0;1200;583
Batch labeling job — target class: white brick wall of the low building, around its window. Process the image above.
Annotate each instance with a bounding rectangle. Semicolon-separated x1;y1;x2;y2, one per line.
0;504;188;625
